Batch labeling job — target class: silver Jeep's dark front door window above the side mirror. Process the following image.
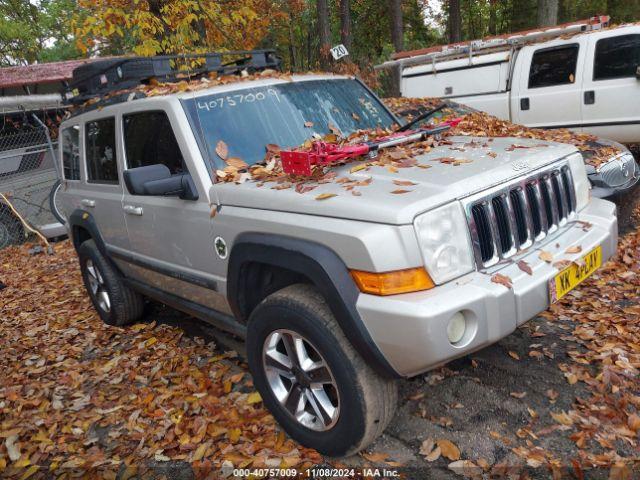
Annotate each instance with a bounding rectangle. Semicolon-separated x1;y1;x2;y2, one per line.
123;112;186;174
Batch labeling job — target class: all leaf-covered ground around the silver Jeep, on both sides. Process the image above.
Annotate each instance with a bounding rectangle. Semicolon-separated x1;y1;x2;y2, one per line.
0;207;640;478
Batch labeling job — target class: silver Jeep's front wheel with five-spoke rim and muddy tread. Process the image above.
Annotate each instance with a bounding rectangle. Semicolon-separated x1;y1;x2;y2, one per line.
247;285;397;456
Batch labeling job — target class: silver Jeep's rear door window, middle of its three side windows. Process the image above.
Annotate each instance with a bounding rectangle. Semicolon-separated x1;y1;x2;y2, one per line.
84;118;118;184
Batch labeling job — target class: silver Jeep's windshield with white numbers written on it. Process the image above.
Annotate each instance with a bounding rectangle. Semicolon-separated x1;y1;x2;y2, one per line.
182;79;396;169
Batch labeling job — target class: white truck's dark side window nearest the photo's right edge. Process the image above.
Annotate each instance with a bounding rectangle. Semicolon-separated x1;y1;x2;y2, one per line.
593;35;640;80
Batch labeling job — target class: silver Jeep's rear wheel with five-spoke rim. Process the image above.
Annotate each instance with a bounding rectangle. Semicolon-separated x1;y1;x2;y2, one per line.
78;240;144;326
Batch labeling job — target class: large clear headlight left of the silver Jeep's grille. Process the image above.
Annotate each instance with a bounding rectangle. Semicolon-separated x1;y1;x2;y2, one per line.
413;202;474;285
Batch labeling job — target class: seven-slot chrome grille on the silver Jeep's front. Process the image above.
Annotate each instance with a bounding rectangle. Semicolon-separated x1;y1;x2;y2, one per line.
465;164;576;268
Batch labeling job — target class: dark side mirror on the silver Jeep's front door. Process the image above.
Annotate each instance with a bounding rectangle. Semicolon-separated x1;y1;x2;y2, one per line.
124;164;198;200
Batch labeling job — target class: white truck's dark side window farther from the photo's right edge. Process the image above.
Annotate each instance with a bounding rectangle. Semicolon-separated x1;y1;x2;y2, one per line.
529;45;579;88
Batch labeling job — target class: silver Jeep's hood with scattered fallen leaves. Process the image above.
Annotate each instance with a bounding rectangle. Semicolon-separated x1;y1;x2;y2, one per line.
211;137;577;225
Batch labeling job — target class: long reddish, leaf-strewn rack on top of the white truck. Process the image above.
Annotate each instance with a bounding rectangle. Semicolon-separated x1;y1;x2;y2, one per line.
375;15;610;70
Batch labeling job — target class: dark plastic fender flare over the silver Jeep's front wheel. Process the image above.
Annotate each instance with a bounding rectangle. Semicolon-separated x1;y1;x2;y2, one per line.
227;233;401;378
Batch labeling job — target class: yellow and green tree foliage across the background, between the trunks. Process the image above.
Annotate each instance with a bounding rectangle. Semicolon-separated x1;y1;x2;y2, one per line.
0;0;640;70
